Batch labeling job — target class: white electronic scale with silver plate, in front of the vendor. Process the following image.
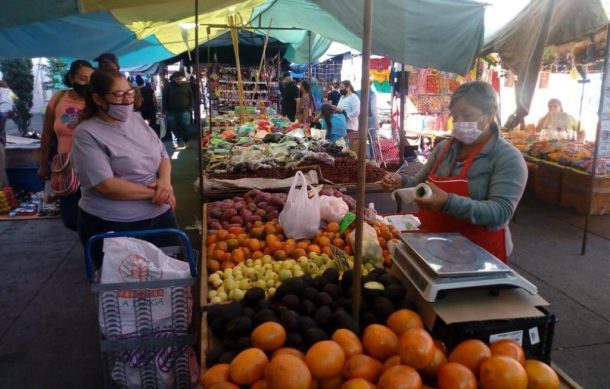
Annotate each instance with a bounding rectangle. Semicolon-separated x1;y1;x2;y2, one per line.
394;233;538;302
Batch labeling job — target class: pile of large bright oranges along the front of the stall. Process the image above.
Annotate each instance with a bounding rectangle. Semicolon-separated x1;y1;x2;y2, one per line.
202;310;559;389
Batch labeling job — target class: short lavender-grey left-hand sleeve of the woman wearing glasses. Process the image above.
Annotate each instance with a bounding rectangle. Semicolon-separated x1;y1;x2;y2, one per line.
71;128;114;189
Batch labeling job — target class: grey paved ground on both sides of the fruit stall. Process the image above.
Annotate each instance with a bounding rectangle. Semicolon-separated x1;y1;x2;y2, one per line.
0;144;610;389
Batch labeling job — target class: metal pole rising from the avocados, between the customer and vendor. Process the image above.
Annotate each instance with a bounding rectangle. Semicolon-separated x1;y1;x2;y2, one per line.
352;0;373;323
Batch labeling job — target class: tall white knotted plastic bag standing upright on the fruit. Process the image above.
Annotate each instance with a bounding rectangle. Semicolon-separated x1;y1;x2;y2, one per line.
279;171;320;239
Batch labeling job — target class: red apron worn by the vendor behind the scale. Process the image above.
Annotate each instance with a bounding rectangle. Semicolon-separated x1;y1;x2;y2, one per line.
417;141;508;262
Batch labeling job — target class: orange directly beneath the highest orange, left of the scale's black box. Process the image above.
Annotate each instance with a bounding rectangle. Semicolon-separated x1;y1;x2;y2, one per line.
398;328;436;370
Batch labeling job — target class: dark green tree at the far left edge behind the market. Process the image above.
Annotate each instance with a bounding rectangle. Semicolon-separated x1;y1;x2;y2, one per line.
0;58;34;134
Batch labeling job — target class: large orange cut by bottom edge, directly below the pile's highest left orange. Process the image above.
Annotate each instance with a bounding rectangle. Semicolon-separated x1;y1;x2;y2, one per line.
265;354;312;389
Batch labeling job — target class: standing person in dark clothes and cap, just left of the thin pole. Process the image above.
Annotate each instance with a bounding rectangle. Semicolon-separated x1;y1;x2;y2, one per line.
162;71;193;149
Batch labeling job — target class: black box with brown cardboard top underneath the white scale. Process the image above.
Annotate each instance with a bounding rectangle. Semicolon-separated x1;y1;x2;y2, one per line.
392;268;556;363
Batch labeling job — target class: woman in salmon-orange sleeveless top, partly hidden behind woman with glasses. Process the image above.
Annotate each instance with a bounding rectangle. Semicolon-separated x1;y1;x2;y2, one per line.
38;60;93;231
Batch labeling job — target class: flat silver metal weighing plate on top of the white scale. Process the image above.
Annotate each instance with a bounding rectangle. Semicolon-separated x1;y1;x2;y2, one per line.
400;233;511;277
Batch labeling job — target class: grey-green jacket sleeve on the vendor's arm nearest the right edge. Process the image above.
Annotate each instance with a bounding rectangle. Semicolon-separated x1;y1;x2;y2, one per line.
443;146;527;230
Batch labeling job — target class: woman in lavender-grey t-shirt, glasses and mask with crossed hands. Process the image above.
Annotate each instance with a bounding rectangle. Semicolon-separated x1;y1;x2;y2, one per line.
72;70;177;268
